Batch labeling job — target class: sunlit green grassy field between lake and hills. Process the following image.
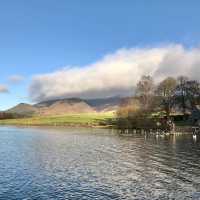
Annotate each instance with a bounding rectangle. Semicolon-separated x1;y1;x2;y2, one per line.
0;113;114;126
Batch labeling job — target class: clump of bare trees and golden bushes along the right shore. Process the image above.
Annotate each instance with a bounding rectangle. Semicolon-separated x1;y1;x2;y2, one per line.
117;76;200;128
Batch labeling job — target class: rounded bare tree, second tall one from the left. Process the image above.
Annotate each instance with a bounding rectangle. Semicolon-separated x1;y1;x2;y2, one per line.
155;77;177;119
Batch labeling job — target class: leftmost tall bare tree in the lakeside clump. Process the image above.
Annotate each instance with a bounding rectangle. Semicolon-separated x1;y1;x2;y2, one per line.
136;76;154;110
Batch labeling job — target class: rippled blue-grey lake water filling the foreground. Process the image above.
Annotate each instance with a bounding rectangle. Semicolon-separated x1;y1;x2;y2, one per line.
0;127;200;200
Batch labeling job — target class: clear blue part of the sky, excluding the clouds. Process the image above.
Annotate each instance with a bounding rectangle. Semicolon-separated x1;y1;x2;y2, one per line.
0;0;200;109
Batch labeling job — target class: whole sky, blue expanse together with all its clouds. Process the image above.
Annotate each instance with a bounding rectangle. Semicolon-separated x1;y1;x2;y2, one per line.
0;0;200;110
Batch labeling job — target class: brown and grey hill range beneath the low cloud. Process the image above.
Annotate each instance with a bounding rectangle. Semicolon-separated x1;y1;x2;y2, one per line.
6;97;122;116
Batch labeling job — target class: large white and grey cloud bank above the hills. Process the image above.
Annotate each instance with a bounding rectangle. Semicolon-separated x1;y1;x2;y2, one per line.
30;44;200;101
